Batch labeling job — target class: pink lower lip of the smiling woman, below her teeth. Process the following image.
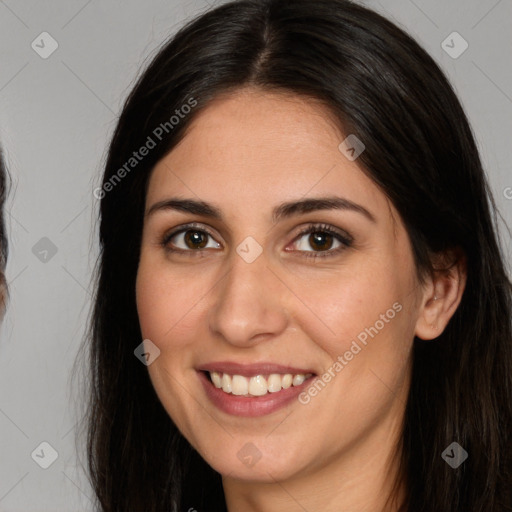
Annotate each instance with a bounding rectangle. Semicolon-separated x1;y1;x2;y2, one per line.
198;371;315;418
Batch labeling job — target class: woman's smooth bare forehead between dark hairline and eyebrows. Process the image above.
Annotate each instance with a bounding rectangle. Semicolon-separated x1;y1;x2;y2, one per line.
148;88;389;222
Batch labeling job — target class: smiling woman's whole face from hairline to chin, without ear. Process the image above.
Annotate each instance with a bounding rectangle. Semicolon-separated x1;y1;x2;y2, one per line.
137;89;425;482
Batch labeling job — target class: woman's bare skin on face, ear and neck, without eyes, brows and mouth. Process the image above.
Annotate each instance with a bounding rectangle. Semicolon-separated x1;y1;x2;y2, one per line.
137;88;465;512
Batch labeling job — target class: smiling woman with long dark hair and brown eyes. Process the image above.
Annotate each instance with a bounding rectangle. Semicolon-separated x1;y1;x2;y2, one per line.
84;0;512;512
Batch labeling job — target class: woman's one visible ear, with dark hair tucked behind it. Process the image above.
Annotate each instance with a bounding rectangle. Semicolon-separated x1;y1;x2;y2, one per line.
414;249;467;340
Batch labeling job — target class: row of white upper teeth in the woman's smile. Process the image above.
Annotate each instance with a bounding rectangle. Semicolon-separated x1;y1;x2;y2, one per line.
209;372;313;396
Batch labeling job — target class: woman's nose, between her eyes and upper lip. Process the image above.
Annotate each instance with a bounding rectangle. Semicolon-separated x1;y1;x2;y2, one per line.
209;247;289;347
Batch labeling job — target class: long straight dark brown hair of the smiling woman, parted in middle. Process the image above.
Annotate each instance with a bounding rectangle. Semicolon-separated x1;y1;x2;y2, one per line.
80;0;512;512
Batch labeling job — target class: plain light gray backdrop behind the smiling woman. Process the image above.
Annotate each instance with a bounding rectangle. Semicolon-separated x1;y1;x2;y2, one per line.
0;0;512;512
